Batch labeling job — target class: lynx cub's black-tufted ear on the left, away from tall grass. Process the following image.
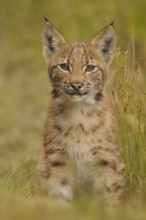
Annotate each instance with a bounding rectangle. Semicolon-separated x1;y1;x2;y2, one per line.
43;18;65;62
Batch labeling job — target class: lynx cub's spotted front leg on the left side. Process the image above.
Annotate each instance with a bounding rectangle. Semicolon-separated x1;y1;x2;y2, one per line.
42;148;73;201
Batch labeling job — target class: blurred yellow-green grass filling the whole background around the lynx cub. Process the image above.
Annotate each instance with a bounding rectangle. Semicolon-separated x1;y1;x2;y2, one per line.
0;0;146;220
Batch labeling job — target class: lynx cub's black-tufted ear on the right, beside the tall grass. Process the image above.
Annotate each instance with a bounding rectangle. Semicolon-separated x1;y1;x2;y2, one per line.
91;23;116;63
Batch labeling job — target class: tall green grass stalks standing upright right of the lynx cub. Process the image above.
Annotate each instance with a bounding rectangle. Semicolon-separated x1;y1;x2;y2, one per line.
113;49;146;199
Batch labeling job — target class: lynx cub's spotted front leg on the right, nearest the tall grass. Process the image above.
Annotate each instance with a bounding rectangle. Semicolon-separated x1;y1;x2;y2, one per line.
92;150;126;204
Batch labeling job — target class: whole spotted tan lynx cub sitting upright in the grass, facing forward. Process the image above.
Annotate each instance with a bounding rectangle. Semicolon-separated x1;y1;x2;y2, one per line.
42;19;125;202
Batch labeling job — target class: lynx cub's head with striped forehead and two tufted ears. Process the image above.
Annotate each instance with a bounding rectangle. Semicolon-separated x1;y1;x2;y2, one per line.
43;19;116;103
